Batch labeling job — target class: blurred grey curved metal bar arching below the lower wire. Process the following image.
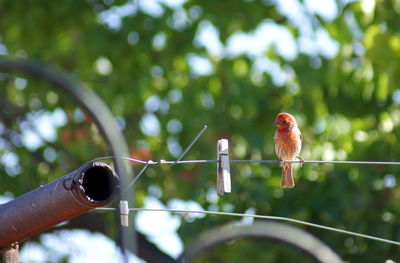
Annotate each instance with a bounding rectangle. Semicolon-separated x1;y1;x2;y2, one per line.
178;222;343;263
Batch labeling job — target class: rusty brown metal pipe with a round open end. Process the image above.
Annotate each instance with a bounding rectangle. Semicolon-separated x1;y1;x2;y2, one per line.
0;162;119;248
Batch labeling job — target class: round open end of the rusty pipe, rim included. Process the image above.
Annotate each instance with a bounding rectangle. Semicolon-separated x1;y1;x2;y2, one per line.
73;162;119;207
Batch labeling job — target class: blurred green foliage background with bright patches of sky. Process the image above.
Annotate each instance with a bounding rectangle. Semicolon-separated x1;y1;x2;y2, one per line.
0;0;400;263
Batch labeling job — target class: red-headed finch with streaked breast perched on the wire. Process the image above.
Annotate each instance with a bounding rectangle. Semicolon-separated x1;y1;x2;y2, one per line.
274;113;303;188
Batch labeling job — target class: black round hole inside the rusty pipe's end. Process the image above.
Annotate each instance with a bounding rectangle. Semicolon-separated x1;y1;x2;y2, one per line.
82;166;117;202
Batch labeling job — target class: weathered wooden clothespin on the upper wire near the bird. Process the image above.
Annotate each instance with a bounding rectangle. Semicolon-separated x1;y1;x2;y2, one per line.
217;139;231;196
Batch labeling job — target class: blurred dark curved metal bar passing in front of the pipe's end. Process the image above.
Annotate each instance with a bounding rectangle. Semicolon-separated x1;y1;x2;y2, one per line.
0;57;135;258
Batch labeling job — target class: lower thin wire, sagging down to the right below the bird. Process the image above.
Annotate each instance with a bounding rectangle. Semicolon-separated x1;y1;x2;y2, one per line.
96;207;400;246
